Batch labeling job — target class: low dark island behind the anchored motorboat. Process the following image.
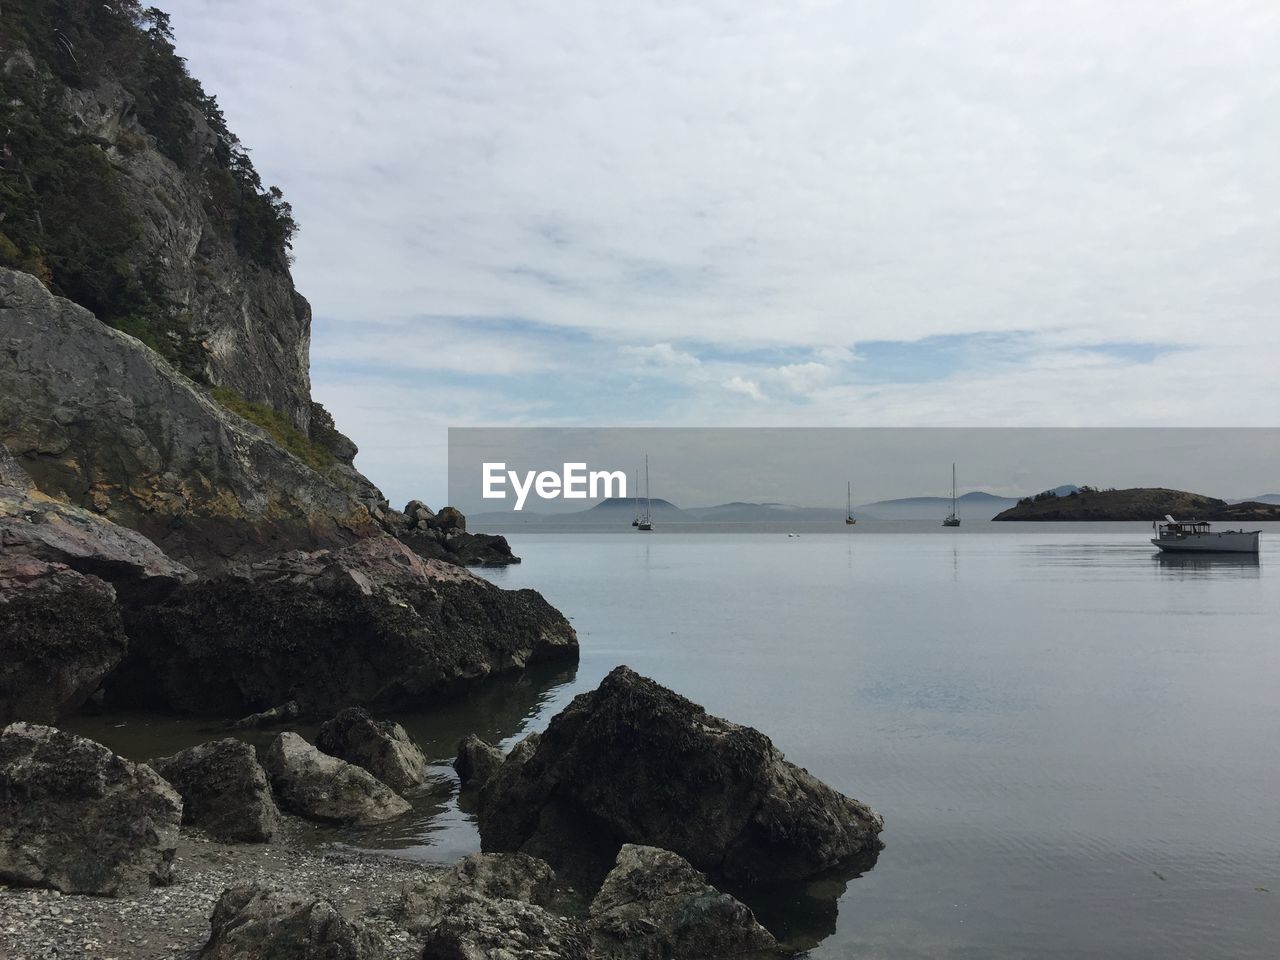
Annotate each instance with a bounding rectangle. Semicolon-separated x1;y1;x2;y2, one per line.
992;486;1280;521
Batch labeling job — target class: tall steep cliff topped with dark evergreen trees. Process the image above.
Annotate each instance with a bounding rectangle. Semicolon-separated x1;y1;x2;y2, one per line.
0;0;312;433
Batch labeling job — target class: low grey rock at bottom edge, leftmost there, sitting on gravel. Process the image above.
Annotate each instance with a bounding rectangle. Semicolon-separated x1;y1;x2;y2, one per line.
200;886;387;960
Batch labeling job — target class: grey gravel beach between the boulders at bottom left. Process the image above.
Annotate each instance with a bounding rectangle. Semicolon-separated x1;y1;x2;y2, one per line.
0;829;440;960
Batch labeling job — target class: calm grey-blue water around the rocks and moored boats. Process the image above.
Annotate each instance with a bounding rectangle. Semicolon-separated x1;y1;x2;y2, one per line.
72;524;1280;959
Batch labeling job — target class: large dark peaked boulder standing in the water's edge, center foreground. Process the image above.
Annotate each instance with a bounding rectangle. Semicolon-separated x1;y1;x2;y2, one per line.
479;667;883;882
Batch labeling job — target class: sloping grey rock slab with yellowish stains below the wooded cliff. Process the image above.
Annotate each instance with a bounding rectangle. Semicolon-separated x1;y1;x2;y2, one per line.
0;265;379;571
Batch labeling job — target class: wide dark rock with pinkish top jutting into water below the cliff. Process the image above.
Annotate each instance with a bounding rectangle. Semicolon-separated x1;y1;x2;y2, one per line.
108;538;577;717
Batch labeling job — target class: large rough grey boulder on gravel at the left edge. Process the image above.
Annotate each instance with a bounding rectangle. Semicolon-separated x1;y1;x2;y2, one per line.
0;723;182;896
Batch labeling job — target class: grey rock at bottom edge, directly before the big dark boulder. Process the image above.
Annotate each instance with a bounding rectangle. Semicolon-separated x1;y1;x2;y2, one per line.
589;844;781;960
